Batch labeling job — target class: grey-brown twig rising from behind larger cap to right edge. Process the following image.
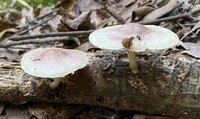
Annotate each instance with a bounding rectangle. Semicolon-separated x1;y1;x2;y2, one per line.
139;9;200;24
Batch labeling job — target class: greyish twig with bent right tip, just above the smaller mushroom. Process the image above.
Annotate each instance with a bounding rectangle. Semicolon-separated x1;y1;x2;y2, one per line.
0;36;80;48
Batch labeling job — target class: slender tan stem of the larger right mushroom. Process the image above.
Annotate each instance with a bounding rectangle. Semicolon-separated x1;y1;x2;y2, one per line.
126;49;139;73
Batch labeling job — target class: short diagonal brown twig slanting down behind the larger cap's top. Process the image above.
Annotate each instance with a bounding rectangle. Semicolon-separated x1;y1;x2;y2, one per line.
105;7;126;24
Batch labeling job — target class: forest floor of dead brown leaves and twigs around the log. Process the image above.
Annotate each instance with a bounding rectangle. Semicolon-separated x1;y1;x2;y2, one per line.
0;0;200;119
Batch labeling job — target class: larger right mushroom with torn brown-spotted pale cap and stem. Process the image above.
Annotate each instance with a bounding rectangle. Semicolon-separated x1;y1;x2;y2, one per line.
89;23;179;73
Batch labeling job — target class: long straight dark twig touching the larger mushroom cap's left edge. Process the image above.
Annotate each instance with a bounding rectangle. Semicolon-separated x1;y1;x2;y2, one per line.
9;30;94;41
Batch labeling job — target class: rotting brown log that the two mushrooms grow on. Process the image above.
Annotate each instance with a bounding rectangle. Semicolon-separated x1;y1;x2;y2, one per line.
0;51;200;117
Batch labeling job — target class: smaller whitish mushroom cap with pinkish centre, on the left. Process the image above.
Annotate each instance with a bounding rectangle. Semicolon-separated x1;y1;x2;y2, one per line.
21;48;88;78
